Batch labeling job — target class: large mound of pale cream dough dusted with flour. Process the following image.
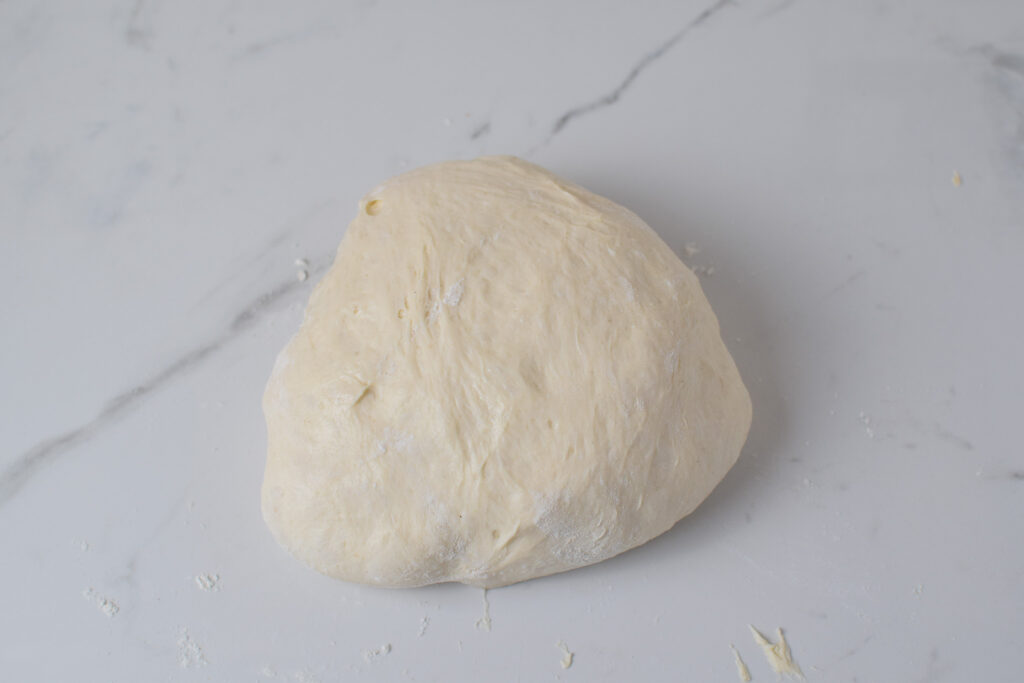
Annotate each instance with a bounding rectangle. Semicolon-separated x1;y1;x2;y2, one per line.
262;157;751;588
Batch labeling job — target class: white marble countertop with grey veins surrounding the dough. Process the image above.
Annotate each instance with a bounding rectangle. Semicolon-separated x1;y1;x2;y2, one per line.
0;0;1024;682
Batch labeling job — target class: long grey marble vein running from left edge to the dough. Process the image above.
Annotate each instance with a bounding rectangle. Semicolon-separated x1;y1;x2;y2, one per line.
0;268;323;507
